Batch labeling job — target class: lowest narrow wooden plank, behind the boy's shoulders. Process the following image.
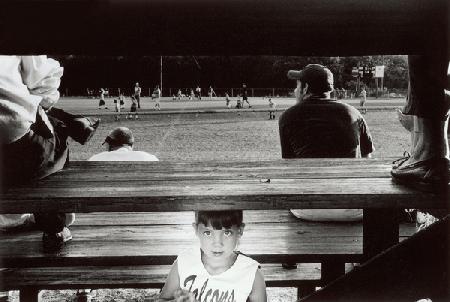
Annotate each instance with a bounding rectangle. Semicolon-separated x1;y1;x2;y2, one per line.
0;263;322;292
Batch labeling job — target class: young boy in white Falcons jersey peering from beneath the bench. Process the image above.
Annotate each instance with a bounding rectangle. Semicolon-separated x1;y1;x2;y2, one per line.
159;210;267;302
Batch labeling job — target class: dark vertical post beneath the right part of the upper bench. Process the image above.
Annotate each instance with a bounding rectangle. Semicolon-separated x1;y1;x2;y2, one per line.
363;209;399;260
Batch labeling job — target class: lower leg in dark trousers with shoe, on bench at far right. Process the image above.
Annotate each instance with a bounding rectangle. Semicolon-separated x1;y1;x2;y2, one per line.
391;54;450;190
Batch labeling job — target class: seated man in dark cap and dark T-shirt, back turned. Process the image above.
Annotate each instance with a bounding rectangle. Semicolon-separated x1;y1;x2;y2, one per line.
279;64;374;221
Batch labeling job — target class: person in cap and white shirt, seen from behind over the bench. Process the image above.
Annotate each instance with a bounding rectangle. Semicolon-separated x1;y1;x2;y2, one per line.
89;127;158;161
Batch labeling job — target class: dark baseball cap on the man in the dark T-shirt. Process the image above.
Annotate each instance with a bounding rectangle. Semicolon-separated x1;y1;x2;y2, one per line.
287;64;334;93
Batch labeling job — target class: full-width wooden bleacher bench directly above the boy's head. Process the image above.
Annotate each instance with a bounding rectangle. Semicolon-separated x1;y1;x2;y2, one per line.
0;159;449;213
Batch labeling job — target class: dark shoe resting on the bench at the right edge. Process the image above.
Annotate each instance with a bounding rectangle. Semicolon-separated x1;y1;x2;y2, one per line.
391;158;449;192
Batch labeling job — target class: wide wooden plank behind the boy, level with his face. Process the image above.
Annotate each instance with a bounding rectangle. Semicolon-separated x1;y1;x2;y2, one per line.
0;221;415;267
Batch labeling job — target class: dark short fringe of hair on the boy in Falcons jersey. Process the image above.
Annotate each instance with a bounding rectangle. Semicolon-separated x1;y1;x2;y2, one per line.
195;210;243;230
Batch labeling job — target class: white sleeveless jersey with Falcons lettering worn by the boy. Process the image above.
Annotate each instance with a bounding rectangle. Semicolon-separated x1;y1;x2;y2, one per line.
177;248;259;302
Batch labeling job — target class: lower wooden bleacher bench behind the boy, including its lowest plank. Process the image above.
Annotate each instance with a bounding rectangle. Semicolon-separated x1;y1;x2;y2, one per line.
0;210;415;301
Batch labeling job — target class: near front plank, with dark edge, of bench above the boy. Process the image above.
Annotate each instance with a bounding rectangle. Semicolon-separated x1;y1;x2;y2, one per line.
0;179;449;213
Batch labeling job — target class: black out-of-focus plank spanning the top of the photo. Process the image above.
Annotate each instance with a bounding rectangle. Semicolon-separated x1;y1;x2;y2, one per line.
0;0;448;56
